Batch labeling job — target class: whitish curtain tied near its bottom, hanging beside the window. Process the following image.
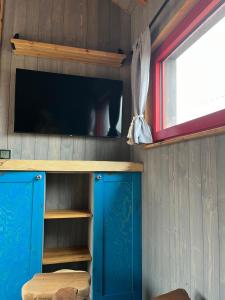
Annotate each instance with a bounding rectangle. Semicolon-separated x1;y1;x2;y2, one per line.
127;27;152;145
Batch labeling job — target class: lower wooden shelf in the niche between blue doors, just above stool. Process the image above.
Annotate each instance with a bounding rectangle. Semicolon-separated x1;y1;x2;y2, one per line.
42;248;92;265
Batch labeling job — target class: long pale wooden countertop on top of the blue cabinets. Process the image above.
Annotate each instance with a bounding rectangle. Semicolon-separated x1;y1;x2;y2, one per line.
0;159;143;173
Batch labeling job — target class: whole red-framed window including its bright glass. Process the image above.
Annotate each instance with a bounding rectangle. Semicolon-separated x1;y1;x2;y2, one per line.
152;0;225;141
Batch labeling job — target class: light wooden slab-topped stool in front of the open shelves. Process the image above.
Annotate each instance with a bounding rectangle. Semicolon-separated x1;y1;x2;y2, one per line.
22;270;90;300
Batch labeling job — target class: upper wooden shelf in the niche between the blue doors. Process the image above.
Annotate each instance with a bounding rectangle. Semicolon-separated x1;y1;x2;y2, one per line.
45;210;92;220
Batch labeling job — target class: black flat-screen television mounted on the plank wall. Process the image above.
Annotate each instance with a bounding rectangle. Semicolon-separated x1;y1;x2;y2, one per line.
14;69;123;138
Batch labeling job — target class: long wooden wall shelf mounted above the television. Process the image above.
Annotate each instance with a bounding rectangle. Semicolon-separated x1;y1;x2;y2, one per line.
11;38;126;68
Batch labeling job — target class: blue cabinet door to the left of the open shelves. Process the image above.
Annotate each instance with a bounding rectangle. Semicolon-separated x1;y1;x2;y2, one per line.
0;172;45;300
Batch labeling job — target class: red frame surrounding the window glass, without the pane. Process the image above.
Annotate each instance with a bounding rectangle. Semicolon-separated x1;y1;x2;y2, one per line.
151;0;225;142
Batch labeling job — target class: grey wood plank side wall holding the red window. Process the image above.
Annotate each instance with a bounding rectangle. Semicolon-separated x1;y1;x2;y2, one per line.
131;0;225;300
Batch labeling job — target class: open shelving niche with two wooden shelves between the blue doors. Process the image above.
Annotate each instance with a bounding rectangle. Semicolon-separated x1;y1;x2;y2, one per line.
42;173;92;272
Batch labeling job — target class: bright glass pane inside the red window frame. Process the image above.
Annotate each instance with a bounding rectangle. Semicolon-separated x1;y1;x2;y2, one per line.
162;12;225;128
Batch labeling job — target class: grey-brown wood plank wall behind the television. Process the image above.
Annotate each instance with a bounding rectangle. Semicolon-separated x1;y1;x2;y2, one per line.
0;0;130;160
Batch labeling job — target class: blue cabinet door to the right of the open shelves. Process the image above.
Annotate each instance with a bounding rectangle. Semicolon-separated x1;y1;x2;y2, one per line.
92;173;142;300
